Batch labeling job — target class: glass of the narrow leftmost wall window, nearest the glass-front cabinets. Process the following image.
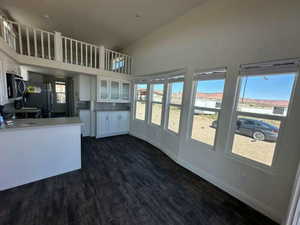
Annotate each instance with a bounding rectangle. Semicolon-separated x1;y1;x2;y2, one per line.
135;84;148;120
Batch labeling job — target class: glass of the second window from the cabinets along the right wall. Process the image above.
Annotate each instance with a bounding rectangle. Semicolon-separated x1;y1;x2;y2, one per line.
151;84;164;126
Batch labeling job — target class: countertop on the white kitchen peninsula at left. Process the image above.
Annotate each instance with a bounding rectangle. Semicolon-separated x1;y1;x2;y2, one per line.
0;117;82;132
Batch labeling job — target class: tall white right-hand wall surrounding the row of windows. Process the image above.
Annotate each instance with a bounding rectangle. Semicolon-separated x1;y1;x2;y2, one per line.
127;0;300;221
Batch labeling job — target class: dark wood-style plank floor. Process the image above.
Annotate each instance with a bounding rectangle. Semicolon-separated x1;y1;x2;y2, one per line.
0;135;275;225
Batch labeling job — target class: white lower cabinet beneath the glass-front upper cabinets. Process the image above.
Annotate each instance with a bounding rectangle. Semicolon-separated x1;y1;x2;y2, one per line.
96;111;130;138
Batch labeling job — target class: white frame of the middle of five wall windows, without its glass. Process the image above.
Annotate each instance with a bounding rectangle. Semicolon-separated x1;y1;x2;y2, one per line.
164;78;185;136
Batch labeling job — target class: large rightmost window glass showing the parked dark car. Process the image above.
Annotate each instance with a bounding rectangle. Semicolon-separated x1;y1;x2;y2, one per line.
232;73;296;166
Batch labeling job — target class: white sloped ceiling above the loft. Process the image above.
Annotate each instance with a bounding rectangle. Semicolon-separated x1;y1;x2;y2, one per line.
0;0;207;49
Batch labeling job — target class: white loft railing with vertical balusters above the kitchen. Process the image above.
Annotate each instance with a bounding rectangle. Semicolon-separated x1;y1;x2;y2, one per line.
0;17;132;74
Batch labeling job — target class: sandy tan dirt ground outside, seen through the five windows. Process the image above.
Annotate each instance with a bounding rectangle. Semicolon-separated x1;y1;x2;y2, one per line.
137;103;276;166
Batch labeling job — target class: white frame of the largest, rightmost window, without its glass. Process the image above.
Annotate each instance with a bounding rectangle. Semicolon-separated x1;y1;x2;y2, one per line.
225;67;300;171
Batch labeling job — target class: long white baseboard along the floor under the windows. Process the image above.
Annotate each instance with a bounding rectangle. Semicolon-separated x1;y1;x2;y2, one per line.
129;132;282;224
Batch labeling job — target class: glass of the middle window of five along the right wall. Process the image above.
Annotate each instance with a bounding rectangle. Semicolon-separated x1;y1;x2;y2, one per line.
167;81;184;134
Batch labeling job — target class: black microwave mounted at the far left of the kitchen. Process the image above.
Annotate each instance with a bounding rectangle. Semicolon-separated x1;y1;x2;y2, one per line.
6;73;26;100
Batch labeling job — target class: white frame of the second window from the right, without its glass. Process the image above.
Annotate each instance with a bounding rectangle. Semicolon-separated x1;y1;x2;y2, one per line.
187;71;227;151
